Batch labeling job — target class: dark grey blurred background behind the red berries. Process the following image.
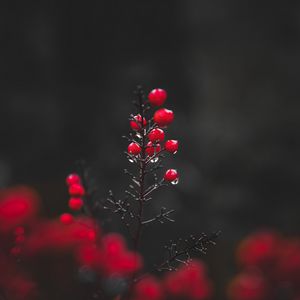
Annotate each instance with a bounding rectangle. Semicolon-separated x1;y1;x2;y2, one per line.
0;0;300;299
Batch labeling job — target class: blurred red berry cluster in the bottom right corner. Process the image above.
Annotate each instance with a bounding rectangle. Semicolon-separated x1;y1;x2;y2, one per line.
228;231;300;300
